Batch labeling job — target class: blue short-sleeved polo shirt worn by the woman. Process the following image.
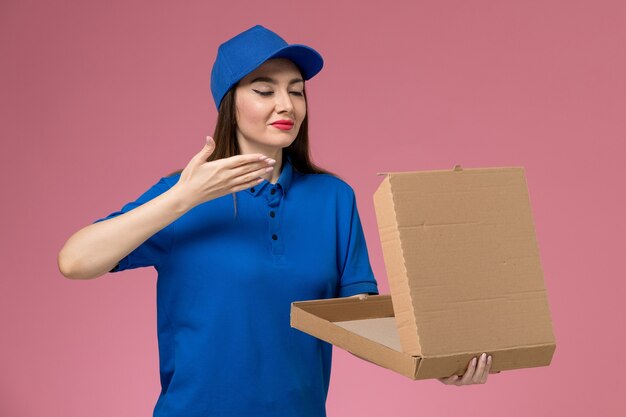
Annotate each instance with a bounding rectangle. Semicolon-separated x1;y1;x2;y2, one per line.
94;157;378;417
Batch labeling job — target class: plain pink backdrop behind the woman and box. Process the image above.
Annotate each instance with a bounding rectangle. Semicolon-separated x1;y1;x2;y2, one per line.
0;0;626;417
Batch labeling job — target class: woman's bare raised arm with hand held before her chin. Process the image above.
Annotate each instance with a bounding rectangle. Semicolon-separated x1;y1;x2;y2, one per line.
57;136;276;279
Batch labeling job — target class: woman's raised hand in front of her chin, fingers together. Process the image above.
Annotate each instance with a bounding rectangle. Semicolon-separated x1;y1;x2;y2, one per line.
174;136;276;207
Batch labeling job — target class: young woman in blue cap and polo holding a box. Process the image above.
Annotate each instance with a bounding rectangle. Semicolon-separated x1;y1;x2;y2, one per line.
59;25;490;417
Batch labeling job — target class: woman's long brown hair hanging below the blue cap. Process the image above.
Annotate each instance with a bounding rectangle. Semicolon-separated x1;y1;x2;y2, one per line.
168;79;341;216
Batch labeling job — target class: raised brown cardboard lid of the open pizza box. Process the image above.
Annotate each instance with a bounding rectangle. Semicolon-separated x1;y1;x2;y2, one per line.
374;165;555;358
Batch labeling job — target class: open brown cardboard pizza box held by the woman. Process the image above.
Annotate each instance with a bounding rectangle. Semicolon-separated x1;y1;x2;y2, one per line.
291;165;556;379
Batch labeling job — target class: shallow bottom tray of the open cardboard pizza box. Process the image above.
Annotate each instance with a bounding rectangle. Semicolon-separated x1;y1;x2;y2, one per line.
290;294;556;379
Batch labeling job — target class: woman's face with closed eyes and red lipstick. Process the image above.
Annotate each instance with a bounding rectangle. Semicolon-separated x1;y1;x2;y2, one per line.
235;58;306;155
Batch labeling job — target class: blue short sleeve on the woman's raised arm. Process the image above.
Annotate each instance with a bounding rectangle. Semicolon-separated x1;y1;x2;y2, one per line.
93;178;173;272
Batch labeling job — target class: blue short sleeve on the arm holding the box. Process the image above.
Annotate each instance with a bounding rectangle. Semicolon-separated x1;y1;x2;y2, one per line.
338;187;378;297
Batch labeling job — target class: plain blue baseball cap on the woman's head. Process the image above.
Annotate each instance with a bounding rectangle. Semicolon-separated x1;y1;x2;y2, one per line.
211;25;324;110
